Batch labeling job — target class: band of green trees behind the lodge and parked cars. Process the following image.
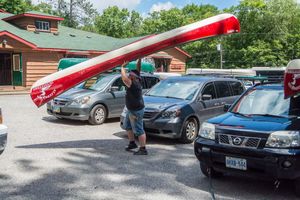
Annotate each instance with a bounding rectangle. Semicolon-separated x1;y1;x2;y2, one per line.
0;0;300;68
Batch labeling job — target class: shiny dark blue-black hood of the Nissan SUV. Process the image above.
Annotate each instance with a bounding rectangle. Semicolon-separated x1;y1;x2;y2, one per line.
208;112;300;132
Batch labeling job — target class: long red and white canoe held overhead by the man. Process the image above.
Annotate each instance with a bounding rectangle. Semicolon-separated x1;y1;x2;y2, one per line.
30;14;240;107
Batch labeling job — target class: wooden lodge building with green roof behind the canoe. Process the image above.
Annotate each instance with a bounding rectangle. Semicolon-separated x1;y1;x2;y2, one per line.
0;9;190;87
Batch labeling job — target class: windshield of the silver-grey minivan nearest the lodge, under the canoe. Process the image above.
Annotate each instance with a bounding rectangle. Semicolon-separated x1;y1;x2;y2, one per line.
82;75;112;91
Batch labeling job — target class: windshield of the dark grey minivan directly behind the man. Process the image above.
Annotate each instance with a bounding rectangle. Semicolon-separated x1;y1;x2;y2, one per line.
146;79;201;100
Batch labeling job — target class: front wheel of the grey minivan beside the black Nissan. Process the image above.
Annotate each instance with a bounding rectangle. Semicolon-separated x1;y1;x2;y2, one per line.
180;117;199;143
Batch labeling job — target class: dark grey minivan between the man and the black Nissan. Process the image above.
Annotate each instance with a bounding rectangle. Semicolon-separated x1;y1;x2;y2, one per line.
121;76;245;143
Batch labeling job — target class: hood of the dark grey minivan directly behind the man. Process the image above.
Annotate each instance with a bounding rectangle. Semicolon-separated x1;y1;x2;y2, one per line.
144;96;187;111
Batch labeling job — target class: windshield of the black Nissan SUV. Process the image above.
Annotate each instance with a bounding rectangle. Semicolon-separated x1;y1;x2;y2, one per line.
231;88;300;117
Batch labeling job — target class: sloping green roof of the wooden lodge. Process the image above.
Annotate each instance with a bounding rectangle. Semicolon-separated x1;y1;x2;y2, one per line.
0;13;142;51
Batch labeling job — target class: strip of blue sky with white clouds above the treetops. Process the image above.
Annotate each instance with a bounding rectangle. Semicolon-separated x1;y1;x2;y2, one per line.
33;0;239;16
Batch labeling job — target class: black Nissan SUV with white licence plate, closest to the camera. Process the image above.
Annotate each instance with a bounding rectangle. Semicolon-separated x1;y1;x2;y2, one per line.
194;84;300;195
